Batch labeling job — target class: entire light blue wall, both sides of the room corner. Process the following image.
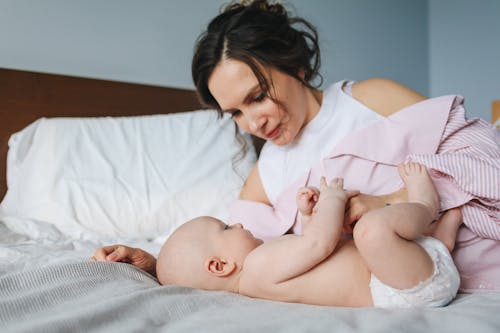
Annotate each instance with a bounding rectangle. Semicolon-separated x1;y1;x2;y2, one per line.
0;0;500;119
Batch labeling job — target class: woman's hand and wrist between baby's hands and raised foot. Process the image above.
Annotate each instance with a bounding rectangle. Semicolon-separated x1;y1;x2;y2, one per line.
344;188;408;233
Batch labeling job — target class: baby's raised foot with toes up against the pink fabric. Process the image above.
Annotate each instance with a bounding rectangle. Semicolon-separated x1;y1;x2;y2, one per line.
398;163;439;219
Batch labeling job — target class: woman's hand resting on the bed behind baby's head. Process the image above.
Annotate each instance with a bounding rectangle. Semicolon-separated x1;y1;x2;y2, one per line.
90;244;156;276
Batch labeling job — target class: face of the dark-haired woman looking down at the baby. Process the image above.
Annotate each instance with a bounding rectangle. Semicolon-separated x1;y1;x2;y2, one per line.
208;59;319;146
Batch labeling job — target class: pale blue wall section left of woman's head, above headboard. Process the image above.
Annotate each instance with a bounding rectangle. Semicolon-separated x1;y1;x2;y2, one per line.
0;0;218;87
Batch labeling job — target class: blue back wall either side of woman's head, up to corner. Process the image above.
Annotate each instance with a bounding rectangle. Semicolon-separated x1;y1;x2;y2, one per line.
0;0;428;93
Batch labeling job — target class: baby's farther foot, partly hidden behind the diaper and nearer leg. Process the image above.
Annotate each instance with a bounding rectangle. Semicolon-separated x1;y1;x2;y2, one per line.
425;208;462;252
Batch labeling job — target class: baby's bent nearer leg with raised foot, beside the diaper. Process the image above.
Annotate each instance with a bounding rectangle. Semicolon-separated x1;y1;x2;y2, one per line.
354;163;439;289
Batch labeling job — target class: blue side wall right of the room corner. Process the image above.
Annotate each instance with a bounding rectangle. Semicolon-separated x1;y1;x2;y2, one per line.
429;0;500;121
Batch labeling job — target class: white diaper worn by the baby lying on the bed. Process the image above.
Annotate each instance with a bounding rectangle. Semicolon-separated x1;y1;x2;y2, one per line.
370;237;460;308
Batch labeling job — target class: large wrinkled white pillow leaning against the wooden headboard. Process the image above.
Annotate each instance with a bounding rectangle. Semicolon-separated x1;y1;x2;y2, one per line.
0;110;256;238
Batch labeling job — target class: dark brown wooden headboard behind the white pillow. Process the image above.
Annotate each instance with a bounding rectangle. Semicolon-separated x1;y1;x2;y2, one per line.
0;68;200;198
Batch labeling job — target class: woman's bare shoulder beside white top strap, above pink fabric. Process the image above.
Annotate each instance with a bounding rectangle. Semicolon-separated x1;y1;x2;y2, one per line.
351;78;427;117
